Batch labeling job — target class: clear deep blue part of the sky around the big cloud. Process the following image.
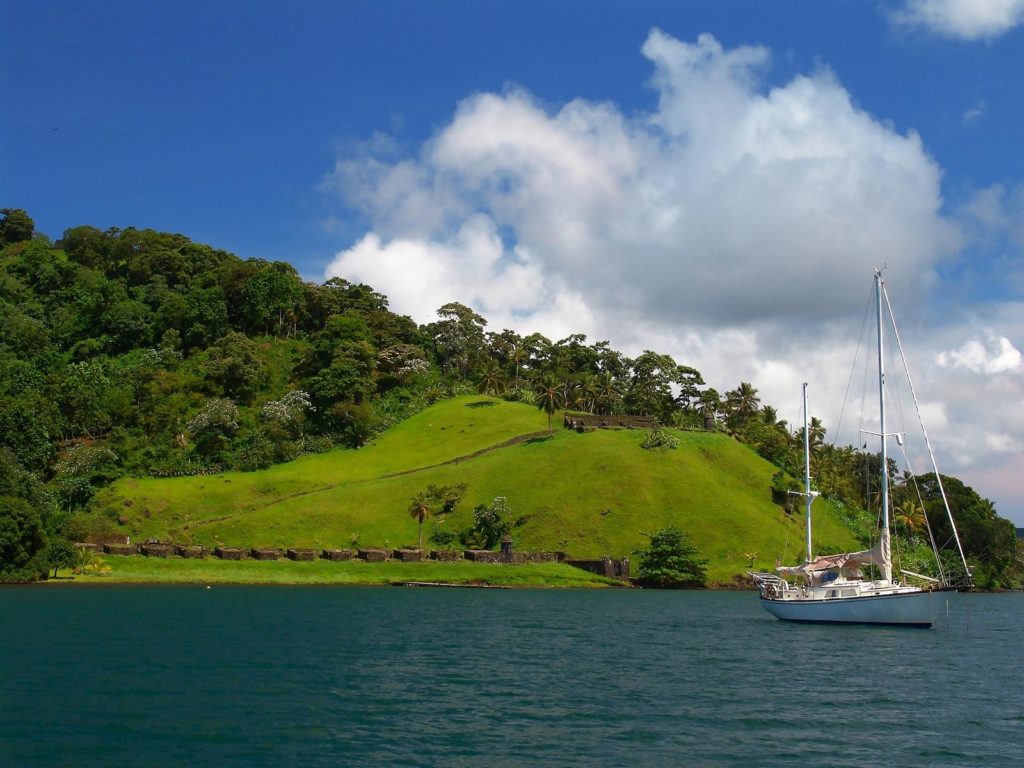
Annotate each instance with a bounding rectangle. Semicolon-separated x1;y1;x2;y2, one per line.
0;0;1024;278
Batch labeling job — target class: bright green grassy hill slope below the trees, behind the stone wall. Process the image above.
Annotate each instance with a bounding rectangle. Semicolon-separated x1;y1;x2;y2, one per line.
97;396;855;582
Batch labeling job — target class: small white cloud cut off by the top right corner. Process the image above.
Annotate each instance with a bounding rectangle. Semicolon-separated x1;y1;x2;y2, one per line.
892;0;1024;40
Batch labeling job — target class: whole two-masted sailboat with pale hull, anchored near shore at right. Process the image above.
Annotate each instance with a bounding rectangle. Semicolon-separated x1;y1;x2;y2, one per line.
750;269;970;628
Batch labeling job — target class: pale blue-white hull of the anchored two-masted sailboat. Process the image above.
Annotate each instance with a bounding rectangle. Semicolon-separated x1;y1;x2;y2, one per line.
761;592;942;628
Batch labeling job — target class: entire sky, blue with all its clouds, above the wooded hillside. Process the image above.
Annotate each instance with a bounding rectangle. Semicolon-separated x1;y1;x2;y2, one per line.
0;0;1024;524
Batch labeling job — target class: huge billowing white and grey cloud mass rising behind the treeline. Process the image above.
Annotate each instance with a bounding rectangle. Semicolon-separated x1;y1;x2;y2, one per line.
325;30;1024;524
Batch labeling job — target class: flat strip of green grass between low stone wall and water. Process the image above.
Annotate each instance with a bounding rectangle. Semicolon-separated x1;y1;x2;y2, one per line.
59;555;618;587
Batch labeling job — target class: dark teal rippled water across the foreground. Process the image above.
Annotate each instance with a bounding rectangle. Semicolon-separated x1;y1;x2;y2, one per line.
0;586;1024;768
